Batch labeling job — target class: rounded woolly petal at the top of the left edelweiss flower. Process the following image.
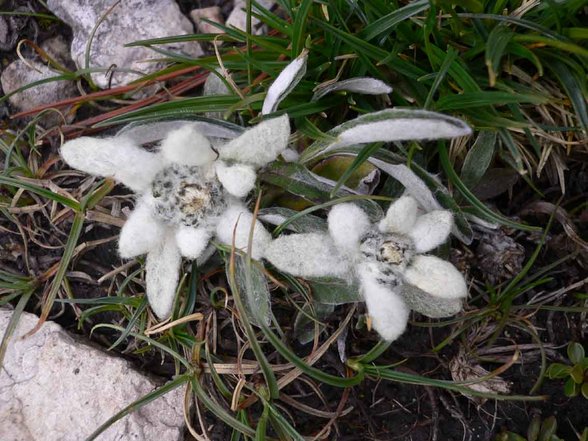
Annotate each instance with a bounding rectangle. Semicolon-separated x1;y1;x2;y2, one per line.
161;125;217;165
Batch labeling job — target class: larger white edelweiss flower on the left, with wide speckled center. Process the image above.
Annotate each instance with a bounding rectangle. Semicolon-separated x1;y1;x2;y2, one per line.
61;116;290;319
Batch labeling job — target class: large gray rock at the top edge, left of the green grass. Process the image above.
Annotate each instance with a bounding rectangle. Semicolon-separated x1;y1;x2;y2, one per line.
47;0;202;88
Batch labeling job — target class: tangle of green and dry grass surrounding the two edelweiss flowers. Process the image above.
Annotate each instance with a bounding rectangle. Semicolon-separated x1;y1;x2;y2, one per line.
0;0;588;439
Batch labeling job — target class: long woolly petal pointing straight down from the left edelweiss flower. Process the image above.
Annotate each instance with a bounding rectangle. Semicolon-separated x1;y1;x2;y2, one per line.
145;231;182;320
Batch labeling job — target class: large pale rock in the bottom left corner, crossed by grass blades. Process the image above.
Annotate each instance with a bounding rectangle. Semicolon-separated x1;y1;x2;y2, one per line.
0;309;184;441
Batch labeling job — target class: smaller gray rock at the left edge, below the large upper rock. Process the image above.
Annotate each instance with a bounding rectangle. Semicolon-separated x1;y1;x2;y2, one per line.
0;60;77;124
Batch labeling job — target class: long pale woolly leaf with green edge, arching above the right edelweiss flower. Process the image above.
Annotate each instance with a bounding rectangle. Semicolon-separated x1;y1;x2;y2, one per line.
300;109;472;163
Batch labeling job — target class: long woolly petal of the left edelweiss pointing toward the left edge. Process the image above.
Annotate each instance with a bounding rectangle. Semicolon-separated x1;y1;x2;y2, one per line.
61;136;162;192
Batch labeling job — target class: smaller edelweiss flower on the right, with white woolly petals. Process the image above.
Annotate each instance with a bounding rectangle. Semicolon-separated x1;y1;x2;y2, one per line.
264;196;467;341
